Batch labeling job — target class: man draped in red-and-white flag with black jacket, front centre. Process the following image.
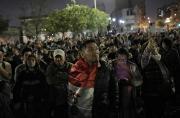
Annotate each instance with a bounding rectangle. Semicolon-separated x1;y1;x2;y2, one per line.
68;40;117;118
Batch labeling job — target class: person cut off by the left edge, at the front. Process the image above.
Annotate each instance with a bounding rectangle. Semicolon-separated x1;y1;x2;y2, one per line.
0;50;13;118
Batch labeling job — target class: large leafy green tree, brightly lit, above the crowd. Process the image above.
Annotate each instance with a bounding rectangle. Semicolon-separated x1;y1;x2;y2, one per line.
45;4;108;33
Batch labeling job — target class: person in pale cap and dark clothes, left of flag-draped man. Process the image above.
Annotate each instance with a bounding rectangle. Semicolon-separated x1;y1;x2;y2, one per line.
46;49;72;118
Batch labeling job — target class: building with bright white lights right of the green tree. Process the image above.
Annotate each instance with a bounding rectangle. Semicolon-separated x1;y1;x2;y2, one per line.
111;0;146;32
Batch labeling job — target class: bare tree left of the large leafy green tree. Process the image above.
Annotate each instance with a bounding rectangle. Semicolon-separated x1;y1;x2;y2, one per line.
20;0;52;39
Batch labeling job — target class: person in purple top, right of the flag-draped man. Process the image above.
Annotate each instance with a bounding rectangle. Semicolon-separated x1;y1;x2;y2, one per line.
113;48;142;118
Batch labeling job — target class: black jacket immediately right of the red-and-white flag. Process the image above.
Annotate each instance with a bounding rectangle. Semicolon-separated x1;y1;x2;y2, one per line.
92;62;118;118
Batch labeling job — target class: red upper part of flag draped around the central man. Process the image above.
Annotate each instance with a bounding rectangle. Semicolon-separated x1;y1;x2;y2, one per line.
68;59;98;88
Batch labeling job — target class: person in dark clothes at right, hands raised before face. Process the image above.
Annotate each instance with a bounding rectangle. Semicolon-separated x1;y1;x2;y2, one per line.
141;39;172;118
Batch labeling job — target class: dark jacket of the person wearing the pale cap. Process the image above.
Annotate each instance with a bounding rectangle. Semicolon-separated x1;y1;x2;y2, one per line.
46;62;72;105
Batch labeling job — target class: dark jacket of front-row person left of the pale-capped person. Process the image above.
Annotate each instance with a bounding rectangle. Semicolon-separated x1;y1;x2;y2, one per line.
13;69;48;103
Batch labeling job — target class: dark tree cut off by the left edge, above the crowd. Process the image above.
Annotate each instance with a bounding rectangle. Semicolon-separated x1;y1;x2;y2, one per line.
0;16;9;34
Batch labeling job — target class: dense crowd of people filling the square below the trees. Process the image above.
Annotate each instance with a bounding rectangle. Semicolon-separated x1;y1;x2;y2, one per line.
0;30;180;118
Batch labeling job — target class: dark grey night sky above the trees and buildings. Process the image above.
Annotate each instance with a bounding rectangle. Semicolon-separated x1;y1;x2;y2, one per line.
0;0;175;26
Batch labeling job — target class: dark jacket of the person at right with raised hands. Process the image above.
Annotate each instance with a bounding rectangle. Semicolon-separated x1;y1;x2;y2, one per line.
143;58;171;97
